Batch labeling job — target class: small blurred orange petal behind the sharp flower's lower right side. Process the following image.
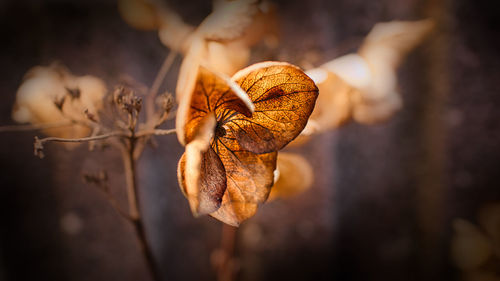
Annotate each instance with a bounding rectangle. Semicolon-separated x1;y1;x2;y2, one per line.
269;152;314;200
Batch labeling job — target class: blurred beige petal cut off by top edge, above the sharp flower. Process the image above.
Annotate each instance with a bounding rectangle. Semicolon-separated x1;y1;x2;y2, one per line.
196;0;258;41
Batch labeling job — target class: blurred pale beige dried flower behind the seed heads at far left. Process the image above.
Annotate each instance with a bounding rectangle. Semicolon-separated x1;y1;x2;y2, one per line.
12;64;106;138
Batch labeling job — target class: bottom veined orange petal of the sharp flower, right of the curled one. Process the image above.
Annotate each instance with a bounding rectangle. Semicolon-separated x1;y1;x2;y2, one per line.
210;134;277;226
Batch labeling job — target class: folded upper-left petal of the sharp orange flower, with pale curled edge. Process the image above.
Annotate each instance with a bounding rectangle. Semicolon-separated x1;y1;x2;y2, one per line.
176;66;253;143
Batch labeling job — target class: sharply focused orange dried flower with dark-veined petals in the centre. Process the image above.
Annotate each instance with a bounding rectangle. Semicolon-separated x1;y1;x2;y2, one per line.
176;62;317;226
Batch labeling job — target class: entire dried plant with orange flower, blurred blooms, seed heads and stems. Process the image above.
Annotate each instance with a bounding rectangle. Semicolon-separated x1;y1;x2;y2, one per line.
0;0;438;280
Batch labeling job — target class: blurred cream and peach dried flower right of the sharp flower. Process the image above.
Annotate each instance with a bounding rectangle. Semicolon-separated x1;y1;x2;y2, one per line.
300;20;433;132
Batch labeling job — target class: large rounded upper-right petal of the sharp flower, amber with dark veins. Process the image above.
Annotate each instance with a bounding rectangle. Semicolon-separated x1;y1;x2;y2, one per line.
223;62;318;153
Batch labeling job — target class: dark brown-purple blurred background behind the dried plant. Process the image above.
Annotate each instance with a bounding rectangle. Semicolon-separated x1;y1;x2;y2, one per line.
0;0;500;280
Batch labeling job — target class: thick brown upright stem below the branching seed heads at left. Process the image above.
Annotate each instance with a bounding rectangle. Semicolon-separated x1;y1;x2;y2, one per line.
122;137;160;281
